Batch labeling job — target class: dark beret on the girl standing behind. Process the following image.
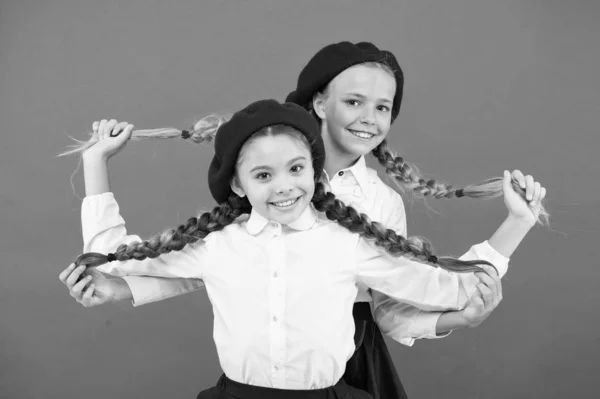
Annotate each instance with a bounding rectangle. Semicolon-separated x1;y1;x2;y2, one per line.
285;42;404;121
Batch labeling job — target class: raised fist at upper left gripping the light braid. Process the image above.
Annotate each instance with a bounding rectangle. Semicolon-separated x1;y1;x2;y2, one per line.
83;119;133;161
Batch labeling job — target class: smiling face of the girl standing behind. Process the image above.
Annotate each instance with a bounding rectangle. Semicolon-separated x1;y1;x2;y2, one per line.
313;65;396;164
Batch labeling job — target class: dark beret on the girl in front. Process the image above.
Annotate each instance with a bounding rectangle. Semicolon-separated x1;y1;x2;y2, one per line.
208;100;325;204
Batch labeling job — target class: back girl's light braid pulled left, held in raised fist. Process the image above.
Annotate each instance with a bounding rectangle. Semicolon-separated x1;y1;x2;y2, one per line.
58;114;231;157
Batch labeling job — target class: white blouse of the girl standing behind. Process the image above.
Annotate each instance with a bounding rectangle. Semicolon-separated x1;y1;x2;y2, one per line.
99;157;509;346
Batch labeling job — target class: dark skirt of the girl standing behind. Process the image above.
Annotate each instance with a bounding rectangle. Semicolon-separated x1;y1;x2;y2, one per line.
343;302;407;399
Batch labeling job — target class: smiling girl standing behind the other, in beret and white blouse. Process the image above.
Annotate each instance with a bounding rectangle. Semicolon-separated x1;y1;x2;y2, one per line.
58;42;545;398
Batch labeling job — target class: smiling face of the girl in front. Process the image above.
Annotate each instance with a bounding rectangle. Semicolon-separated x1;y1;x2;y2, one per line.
231;134;315;224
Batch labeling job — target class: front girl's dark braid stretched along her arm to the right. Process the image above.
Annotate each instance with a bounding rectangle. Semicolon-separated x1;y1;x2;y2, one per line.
312;183;494;273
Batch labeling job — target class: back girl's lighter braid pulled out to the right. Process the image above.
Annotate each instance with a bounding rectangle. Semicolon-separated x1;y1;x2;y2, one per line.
372;140;549;224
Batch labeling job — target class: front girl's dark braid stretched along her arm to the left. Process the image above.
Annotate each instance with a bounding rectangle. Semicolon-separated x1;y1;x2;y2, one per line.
75;194;251;267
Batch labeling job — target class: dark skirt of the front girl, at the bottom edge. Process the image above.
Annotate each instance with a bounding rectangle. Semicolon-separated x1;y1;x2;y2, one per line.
196;374;373;399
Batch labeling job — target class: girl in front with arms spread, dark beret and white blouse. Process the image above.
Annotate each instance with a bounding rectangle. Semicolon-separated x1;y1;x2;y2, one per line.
61;100;508;398
